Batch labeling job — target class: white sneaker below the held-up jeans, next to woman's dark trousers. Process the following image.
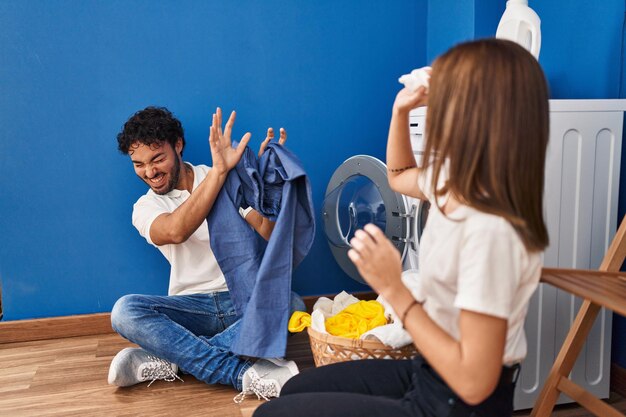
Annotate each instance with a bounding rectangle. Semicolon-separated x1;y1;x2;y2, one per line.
233;359;299;404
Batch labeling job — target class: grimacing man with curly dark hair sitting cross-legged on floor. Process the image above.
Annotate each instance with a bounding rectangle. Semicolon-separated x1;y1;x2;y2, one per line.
108;107;303;398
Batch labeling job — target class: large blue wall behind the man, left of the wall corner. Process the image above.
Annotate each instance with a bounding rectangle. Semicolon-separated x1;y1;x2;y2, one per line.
0;0;426;320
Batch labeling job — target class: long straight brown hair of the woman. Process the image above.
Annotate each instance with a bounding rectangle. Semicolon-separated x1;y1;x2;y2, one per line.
422;39;549;251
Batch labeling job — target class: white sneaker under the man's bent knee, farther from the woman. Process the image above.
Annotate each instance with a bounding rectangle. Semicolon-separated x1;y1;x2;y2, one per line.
109;348;182;387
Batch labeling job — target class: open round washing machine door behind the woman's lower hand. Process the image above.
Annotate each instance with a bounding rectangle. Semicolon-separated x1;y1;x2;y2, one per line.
322;155;428;283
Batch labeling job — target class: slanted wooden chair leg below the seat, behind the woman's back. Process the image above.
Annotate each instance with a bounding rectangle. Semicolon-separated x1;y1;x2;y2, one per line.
530;300;600;417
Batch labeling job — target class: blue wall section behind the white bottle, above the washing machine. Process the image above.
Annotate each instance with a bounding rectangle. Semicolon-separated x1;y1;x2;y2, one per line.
426;0;624;99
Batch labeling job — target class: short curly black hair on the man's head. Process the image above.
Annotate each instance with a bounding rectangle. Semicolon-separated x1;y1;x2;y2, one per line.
117;106;185;156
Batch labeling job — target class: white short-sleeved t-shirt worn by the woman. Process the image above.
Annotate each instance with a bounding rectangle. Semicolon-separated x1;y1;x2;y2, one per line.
416;167;542;365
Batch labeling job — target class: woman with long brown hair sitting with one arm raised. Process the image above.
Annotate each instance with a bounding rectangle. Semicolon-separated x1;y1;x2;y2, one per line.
254;39;549;417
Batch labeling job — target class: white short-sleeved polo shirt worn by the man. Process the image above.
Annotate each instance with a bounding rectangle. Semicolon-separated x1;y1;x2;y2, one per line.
132;164;250;295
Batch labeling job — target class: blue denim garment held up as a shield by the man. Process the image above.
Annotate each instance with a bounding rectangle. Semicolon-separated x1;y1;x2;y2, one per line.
207;143;315;358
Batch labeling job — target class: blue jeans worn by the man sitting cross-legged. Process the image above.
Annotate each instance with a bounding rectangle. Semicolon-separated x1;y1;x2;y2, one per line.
111;292;304;390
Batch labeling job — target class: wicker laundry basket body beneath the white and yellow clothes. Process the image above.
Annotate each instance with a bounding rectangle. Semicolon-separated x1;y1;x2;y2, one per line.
307;327;417;366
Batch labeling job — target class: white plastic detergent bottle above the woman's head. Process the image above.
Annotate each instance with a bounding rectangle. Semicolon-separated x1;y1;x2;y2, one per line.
496;0;541;59
